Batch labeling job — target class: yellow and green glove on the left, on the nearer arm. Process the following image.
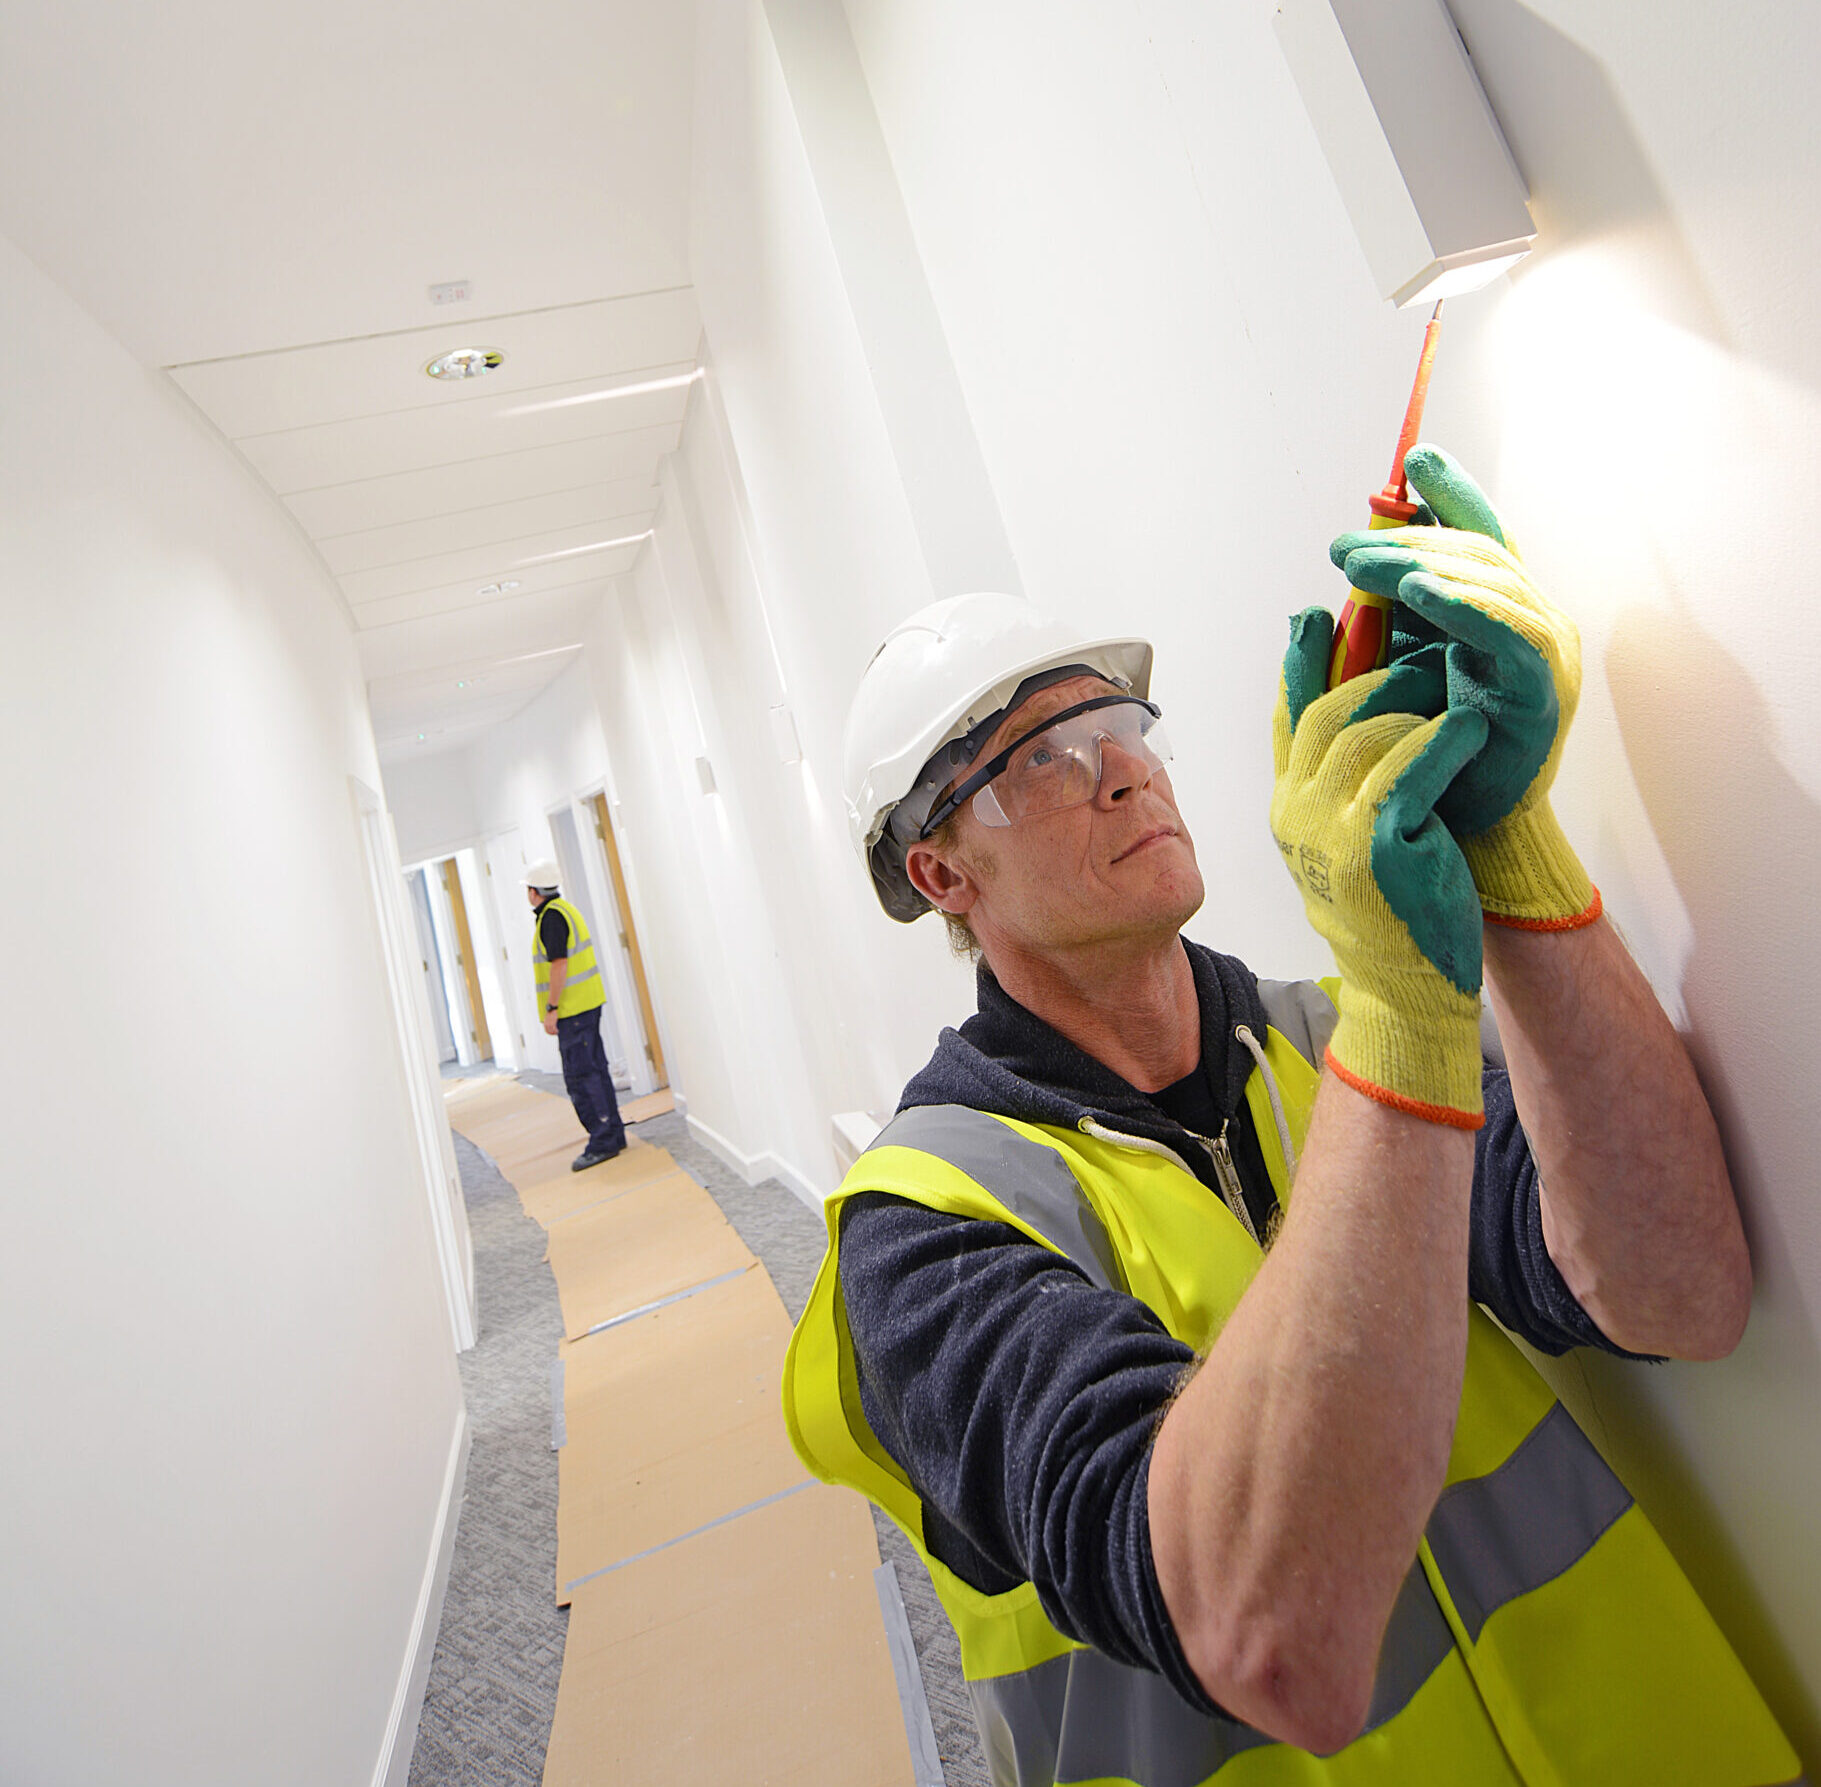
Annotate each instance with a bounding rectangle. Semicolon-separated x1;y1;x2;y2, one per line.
1271;608;1488;1129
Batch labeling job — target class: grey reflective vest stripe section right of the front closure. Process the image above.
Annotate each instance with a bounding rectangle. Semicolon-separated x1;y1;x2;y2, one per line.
1424;1403;1632;1641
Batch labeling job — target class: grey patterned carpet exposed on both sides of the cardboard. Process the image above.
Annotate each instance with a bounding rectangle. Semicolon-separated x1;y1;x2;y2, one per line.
410;1073;991;1787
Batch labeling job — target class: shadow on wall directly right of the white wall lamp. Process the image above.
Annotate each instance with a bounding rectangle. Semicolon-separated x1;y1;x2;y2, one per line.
1450;0;1735;350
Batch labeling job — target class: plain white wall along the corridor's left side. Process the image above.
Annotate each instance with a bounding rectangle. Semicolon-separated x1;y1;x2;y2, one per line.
0;242;463;1787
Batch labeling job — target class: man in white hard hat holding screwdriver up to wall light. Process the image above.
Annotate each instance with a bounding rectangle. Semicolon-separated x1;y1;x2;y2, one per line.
783;448;1801;1787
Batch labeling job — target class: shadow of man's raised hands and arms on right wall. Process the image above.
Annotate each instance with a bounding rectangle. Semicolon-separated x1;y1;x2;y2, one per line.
1586;601;1821;1763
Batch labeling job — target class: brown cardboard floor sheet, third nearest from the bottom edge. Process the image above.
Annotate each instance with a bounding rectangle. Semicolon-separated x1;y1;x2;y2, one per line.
550;1173;752;1341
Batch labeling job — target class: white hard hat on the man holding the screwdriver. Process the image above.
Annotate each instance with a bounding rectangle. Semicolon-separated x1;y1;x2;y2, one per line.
841;592;1151;924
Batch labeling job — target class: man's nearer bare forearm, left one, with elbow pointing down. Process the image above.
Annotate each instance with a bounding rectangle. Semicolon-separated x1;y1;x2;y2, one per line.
1149;1077;1473;1751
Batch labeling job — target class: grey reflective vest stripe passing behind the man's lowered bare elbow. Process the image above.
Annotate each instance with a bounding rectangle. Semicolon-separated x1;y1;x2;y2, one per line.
967;1565;1453;1787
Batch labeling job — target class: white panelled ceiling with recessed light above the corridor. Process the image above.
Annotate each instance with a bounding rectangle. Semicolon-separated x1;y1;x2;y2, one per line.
0;0;701;758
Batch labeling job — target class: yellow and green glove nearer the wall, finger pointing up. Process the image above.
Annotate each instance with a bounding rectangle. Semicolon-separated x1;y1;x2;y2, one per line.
1328;446;1601;931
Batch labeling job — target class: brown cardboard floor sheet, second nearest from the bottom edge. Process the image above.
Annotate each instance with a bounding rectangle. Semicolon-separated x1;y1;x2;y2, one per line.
555;1266;805;1607
